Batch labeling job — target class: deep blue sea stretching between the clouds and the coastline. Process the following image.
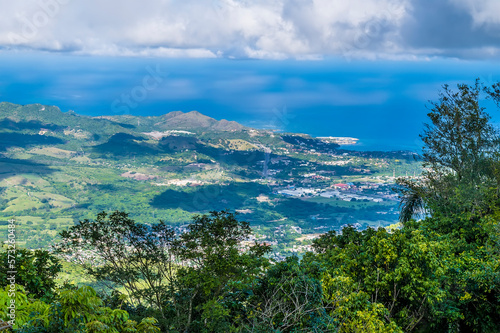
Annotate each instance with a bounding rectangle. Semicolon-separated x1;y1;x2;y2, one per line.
0;52;500;151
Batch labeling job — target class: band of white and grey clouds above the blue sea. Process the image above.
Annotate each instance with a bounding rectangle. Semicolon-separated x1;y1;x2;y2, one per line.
0;0;500;59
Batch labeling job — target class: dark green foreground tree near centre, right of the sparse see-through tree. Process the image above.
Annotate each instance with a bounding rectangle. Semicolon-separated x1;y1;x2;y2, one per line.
172;210;270;332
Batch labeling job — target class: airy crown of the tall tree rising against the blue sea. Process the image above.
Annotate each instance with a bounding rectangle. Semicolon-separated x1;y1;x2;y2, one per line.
420;81;500;180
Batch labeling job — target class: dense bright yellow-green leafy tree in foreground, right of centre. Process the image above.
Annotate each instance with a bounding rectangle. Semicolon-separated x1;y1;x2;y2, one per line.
307;227;447;332
